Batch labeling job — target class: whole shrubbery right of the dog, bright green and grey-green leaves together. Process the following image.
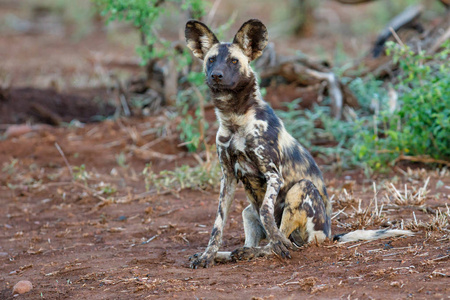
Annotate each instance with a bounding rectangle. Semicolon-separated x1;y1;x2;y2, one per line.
277;41;450;174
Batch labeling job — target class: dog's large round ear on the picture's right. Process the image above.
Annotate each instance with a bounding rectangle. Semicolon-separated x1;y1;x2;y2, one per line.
233;19;268;60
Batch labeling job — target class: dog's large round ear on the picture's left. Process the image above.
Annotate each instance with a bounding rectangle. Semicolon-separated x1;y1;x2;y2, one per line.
184;20;219;59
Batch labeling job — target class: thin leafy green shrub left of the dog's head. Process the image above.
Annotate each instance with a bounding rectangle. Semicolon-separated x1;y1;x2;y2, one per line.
94;0;211;151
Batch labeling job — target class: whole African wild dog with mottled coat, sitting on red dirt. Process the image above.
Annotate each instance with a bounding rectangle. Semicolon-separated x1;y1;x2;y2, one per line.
185;19;414;268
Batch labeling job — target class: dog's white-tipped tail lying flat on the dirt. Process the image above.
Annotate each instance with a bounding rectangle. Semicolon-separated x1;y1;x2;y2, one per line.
333;229;414;243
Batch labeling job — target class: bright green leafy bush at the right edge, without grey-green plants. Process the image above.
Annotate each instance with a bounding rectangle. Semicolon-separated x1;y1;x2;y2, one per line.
353;41;450;170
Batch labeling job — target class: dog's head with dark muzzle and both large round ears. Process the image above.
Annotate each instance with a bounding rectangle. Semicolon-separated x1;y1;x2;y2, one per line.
185;19;267;91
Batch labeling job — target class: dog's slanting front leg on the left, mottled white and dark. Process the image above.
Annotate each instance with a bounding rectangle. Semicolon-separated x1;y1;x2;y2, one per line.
190;172;237;269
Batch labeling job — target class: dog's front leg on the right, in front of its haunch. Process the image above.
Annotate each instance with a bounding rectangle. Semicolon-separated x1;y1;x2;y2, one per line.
259;173;293;258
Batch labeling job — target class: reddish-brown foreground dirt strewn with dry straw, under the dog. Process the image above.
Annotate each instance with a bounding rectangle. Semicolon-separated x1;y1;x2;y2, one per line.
0;118;450;299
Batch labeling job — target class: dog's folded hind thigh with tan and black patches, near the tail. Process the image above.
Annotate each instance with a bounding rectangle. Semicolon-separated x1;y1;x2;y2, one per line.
280;179;331;246
